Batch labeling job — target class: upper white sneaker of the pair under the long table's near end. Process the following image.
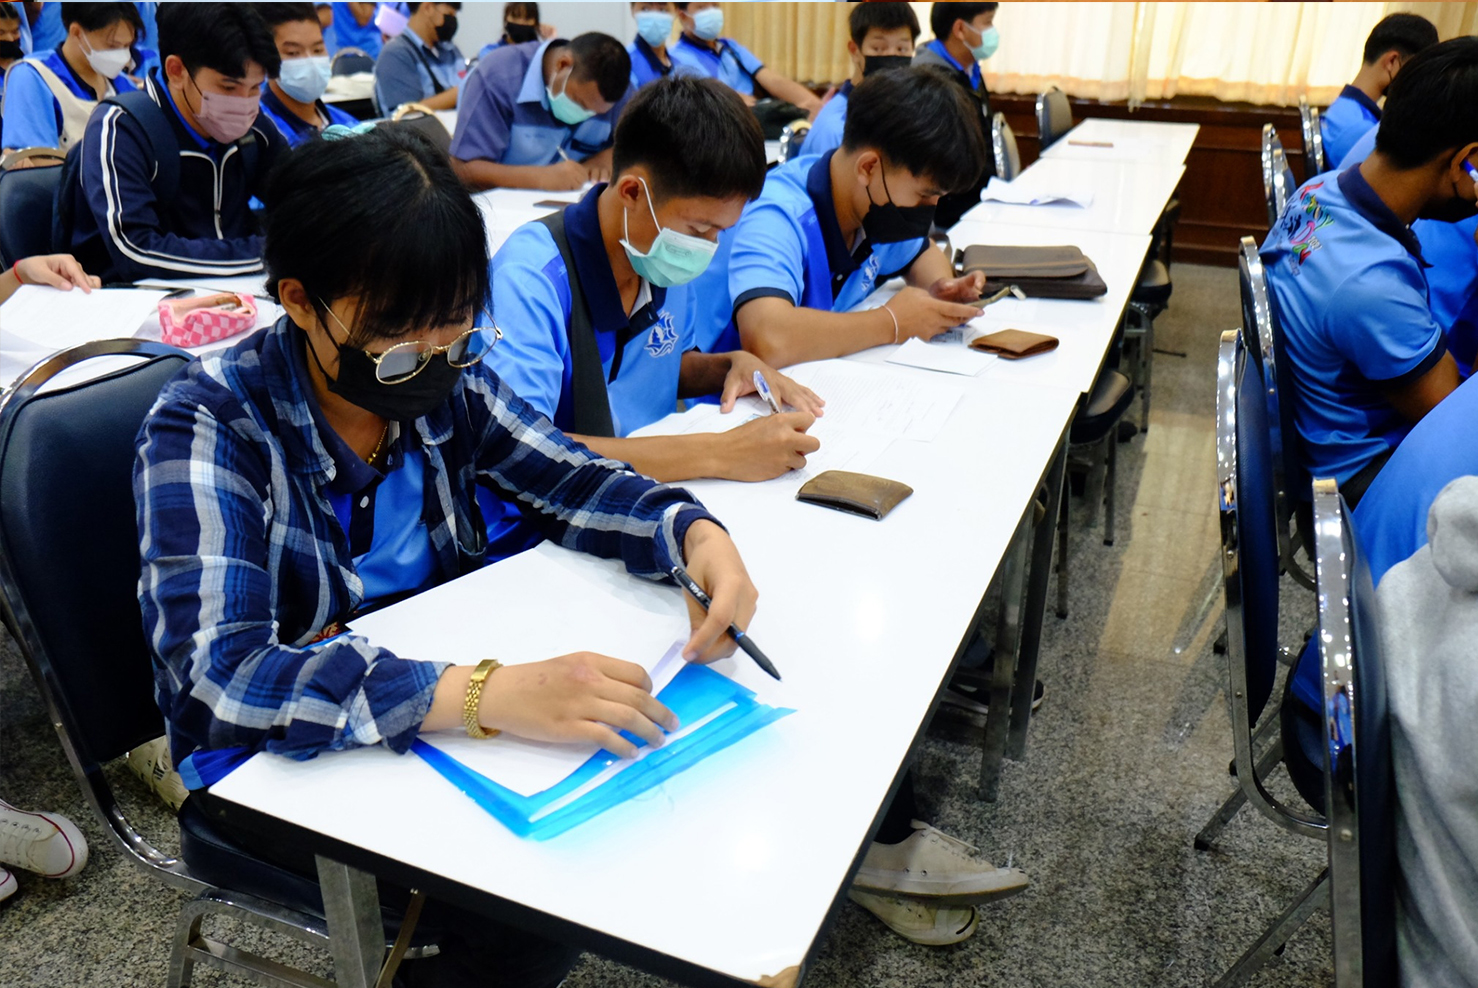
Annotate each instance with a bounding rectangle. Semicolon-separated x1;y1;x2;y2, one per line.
853;819;1030;904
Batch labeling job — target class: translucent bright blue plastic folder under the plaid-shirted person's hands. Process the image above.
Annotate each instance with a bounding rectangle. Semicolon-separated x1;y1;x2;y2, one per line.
411;666;795;840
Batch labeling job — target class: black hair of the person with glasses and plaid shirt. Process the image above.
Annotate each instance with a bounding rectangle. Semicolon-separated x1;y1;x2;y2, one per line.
262;127;488;345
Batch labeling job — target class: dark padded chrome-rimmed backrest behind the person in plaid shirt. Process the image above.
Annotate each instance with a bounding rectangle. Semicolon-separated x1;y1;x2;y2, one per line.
0;340;195;887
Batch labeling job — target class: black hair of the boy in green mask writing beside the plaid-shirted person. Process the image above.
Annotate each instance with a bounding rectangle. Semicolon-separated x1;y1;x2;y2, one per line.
610;75;766;201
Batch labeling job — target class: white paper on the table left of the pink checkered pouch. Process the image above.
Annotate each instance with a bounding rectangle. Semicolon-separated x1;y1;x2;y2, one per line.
0;285;168;352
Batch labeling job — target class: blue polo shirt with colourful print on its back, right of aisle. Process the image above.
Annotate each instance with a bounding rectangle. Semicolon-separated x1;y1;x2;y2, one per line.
1261;169;1447;491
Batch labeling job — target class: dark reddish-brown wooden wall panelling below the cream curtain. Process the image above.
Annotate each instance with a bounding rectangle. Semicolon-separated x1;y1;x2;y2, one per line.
990;96;1304;266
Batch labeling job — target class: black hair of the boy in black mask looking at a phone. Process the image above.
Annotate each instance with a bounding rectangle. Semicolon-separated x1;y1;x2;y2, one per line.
841;65;986;192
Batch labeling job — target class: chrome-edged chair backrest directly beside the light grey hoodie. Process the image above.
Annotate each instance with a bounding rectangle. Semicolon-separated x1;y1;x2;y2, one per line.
1314;481;1398;988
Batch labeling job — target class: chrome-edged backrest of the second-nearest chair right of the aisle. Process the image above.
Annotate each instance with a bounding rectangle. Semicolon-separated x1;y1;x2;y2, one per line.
1216;330;1323;836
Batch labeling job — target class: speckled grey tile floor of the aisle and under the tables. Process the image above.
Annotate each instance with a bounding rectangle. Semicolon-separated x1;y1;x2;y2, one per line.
0;265;1333;988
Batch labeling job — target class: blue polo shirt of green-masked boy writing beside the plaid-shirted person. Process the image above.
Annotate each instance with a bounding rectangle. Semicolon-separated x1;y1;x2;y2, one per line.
488;185;693;436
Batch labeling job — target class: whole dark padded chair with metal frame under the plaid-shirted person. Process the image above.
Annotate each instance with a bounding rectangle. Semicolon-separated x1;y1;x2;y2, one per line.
0;340;435;988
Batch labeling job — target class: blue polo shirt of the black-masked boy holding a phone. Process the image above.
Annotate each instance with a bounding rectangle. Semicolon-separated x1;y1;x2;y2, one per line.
692;152;928;353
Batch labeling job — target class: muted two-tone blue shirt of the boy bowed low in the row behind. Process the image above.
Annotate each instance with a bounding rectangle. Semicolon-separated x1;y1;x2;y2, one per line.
451;38;633;164
